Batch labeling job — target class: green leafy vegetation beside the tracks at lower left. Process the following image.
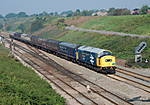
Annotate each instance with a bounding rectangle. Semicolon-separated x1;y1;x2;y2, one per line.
0;45;66;105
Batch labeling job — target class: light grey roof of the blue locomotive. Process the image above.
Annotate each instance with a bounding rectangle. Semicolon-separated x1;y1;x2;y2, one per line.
78;46;106;54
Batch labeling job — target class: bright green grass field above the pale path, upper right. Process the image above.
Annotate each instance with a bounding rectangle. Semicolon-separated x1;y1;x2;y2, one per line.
81;15;150;35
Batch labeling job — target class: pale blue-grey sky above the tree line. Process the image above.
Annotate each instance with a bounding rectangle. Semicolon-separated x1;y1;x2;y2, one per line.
0;0;150;15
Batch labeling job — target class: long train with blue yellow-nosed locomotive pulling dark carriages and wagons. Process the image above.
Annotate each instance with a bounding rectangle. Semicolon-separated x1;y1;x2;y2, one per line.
9;32;116;74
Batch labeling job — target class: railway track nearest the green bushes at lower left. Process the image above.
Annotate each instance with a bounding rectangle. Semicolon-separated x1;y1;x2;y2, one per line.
15;49;98;105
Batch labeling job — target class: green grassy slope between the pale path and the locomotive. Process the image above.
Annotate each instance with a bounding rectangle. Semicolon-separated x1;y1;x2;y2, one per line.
58;31;150;67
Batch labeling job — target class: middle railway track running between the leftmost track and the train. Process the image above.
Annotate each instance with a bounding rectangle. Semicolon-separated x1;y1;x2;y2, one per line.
12;41;132;105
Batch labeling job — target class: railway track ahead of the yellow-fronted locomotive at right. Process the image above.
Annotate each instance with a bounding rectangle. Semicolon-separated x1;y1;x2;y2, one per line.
108;69;150;93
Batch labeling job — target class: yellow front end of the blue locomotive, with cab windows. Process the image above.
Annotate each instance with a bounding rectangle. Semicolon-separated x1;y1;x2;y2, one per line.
97;50;116;73
